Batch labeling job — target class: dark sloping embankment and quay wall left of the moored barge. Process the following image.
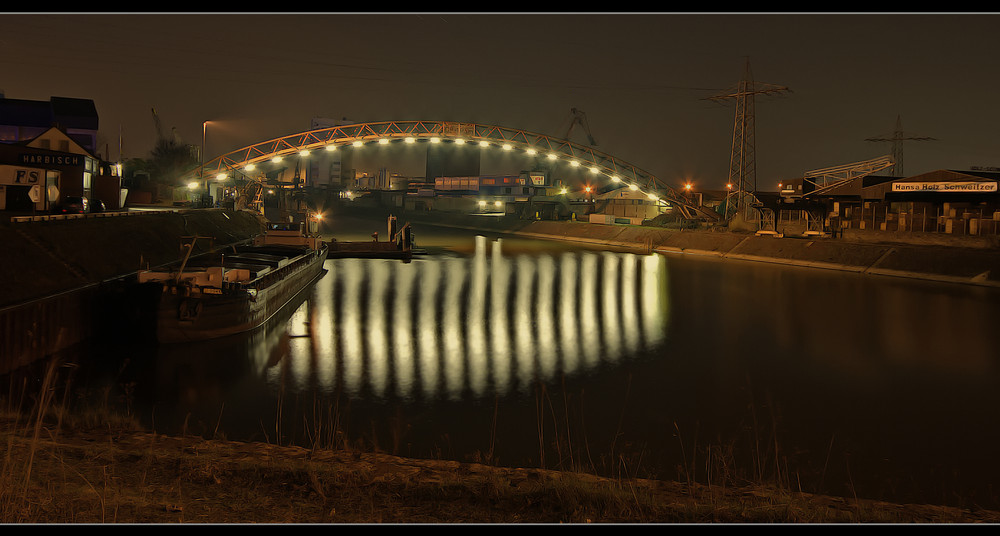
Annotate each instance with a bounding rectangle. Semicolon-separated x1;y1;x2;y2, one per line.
0;210;264;374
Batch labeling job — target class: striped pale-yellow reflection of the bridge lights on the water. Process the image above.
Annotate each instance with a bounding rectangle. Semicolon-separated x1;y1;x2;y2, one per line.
270;241;669;399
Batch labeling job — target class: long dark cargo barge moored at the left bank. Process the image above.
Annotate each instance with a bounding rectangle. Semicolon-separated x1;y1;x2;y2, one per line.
138;223;329;343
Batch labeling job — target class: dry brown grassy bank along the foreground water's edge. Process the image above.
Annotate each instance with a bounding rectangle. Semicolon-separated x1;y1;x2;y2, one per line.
0;361;1000;524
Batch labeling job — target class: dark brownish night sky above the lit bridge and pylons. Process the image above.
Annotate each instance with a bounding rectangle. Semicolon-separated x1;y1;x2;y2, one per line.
0;13;1000;189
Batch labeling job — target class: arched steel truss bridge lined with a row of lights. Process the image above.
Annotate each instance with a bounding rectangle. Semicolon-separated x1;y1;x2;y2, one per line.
188;121;719;219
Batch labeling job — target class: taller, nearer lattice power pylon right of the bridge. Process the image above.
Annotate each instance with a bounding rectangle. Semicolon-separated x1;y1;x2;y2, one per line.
706;58;791;224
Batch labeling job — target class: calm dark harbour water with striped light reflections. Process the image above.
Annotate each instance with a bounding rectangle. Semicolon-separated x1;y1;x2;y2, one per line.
43;225;1000;508
